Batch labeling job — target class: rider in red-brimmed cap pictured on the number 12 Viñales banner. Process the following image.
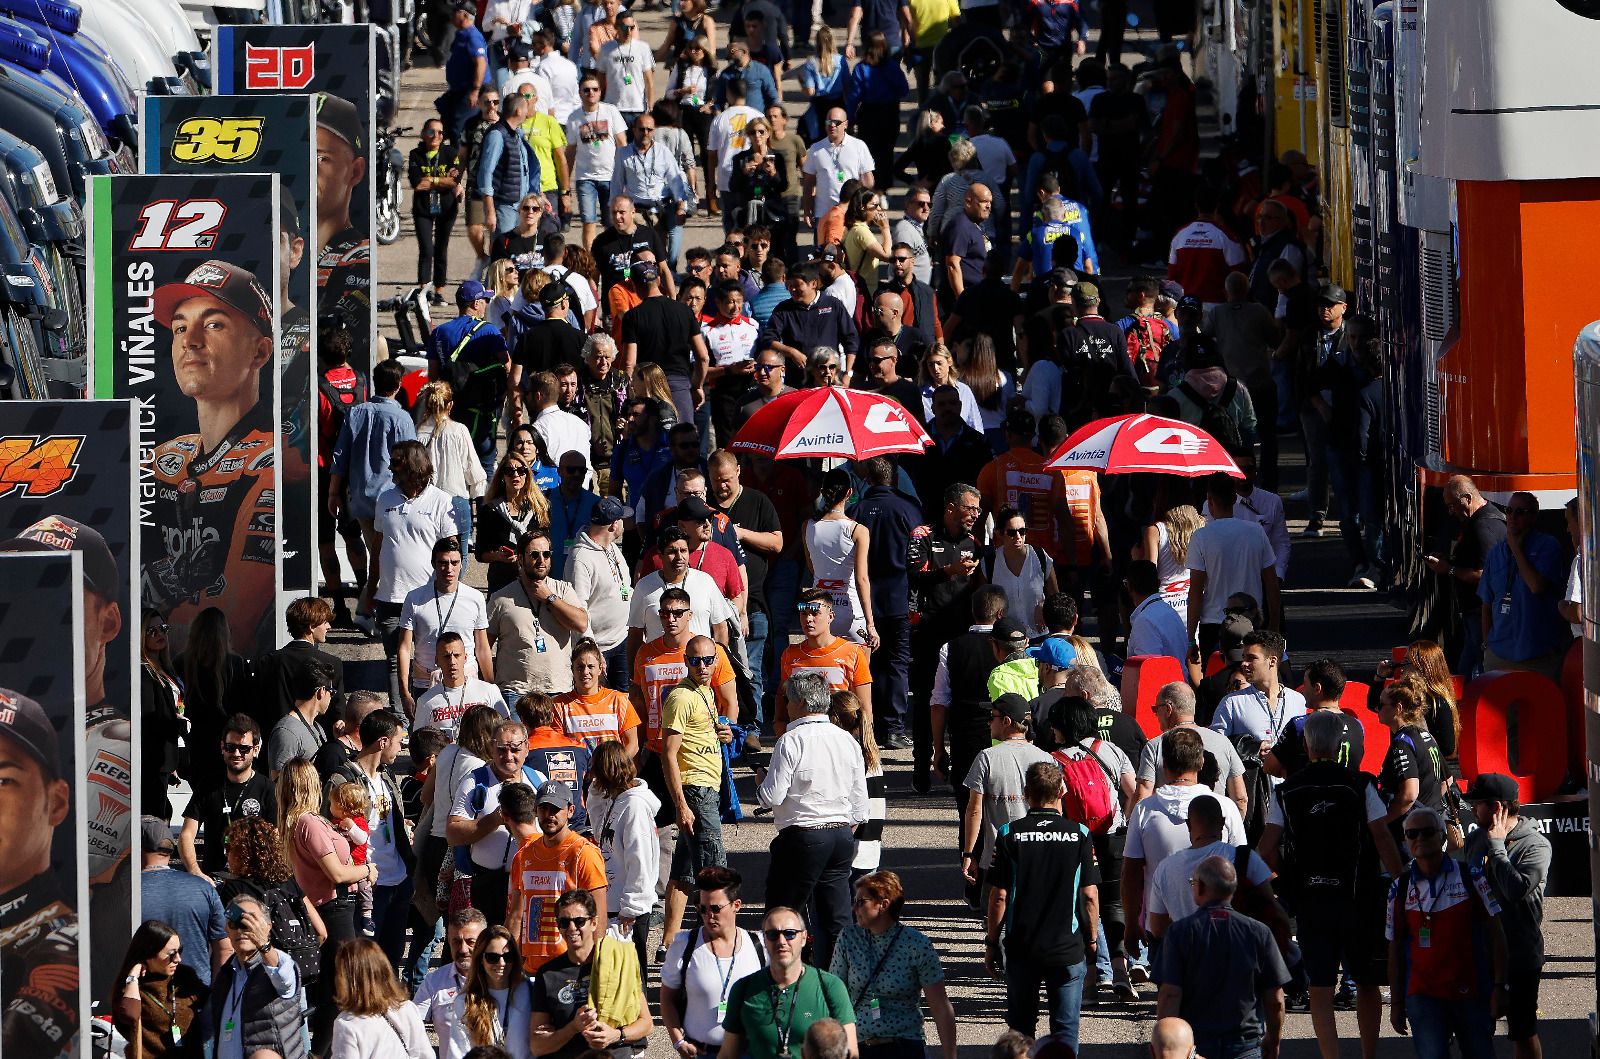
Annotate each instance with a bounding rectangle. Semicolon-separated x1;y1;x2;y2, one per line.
144;261;277;653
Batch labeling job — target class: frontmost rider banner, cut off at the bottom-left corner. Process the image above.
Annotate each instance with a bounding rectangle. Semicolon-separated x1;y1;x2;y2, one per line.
0;552;85;1059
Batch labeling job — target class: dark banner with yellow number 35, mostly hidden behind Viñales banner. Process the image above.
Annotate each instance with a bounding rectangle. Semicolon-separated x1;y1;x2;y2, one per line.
142;96;317;595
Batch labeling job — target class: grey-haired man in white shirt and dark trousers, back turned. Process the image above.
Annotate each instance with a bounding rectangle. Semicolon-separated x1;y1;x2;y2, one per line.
755;673;867;965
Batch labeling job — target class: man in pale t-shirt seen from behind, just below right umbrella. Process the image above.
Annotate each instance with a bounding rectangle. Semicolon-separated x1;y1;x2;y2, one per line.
1187;474;1283;659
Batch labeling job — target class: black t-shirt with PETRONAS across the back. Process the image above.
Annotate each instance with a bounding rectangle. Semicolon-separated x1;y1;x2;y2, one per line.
989;809;1099;968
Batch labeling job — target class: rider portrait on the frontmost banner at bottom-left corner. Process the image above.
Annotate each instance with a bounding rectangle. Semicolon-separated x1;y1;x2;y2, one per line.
0;689;78;1057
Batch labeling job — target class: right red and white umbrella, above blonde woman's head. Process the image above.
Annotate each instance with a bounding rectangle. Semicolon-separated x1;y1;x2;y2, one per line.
1045;413;1245;478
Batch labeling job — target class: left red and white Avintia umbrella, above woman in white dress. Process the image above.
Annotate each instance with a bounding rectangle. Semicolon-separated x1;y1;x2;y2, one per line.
728;386;933;459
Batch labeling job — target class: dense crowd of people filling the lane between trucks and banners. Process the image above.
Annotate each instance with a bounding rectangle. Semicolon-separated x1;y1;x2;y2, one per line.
116;0;1581;1059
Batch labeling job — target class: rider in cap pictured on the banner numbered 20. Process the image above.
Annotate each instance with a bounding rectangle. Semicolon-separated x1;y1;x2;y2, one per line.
308;93;373;335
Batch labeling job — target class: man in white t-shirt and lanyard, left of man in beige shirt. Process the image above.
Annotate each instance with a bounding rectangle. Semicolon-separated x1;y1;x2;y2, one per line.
395;537;494;717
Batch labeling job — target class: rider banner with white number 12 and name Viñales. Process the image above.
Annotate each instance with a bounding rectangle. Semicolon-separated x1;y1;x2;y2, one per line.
90;174;286;659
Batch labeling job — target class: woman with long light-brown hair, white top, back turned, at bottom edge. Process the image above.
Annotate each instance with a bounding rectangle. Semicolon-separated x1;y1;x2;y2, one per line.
328;937;434;1059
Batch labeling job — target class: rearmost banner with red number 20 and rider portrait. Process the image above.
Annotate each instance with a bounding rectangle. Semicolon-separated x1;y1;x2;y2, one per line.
211;26;378;368
